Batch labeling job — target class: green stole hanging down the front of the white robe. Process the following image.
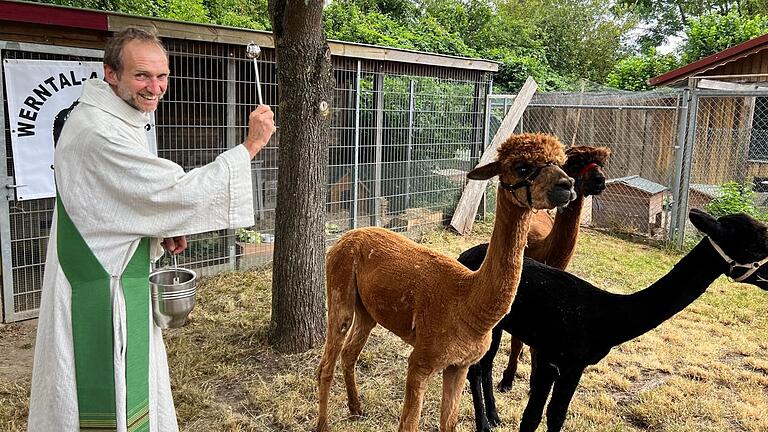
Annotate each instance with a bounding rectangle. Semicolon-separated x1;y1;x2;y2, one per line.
56;196;150;432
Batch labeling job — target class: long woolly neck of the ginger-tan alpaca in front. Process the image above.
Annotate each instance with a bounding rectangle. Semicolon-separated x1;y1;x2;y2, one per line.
467;187;532;333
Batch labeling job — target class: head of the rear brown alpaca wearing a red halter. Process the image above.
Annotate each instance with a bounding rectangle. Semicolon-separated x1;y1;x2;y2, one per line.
563;146;611;197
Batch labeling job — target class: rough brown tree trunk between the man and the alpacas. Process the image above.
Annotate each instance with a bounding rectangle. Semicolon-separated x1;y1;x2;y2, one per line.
269;0;333;353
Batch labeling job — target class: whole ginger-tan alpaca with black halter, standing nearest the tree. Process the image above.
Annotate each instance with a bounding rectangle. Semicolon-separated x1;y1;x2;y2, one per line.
317;134;575;432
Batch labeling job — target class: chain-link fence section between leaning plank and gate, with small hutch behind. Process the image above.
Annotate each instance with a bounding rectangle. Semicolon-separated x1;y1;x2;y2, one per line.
490;91;682;238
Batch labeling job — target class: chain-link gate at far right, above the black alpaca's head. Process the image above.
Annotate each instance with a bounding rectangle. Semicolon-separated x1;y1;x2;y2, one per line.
672;75;768;247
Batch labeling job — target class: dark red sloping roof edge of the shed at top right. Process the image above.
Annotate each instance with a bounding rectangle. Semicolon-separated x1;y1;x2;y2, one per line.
648;33;768;87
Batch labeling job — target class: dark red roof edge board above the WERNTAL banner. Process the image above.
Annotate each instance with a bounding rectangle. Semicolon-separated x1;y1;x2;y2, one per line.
0;0;109;31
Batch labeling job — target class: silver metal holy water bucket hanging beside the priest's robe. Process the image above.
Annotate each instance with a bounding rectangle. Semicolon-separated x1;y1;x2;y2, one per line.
149;251;197;329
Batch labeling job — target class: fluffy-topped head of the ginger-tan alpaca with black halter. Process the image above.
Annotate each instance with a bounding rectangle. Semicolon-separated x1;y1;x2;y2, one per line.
467;134;576;209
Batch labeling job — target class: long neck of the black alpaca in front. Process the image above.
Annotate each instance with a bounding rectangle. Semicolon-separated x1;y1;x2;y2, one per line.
602;238;728;345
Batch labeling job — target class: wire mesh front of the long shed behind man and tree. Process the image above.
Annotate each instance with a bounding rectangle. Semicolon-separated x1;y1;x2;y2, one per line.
0;38;490;321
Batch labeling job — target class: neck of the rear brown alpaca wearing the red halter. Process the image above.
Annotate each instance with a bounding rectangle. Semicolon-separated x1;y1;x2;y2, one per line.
539;194;584;270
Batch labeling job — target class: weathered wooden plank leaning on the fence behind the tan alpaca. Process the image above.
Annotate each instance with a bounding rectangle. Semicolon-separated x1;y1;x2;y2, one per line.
451;77;539;235
